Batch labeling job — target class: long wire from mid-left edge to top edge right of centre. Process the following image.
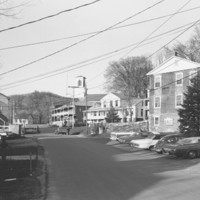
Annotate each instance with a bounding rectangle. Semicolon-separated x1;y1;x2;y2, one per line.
0;0;165;76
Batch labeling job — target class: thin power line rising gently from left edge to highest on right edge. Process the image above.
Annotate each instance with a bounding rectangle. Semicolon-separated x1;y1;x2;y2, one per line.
0;6;200;51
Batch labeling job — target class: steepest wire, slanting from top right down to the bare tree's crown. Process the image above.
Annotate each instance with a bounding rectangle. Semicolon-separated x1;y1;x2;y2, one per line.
124;0;192;56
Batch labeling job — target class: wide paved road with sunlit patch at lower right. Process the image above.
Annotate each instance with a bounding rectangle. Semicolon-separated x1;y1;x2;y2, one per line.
41;136;200;200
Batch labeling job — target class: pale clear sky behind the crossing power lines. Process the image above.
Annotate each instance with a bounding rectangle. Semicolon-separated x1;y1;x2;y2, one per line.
0;0;200;96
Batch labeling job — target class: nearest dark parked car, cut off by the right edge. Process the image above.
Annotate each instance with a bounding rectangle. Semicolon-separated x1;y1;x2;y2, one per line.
163;137;200;158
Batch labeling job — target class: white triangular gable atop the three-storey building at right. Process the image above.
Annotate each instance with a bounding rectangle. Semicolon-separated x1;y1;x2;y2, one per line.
147;56;200;76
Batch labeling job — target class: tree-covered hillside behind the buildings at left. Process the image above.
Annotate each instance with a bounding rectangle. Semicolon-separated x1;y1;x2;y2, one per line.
10;91;71;124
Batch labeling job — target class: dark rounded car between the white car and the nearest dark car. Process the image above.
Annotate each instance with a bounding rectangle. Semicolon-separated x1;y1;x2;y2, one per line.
153;134;184;153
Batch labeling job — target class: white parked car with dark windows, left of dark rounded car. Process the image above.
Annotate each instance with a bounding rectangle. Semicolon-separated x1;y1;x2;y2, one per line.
130;134;164;150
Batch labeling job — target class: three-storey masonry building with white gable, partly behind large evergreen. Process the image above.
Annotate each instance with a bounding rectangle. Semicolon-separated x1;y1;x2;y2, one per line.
147;56;200;132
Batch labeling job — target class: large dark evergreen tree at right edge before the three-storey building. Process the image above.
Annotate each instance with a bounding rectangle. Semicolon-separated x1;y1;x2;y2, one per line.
178;74;200;136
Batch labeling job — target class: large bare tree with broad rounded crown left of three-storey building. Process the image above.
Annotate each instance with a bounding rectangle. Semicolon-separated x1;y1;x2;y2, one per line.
105;56;152;120
